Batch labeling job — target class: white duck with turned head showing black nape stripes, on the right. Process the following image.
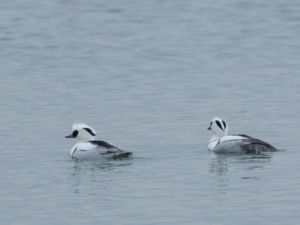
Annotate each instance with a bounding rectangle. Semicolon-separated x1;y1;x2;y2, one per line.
208;117;277;154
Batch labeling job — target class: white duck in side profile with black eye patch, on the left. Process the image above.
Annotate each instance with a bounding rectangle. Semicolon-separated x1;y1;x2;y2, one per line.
65;123;132;159
